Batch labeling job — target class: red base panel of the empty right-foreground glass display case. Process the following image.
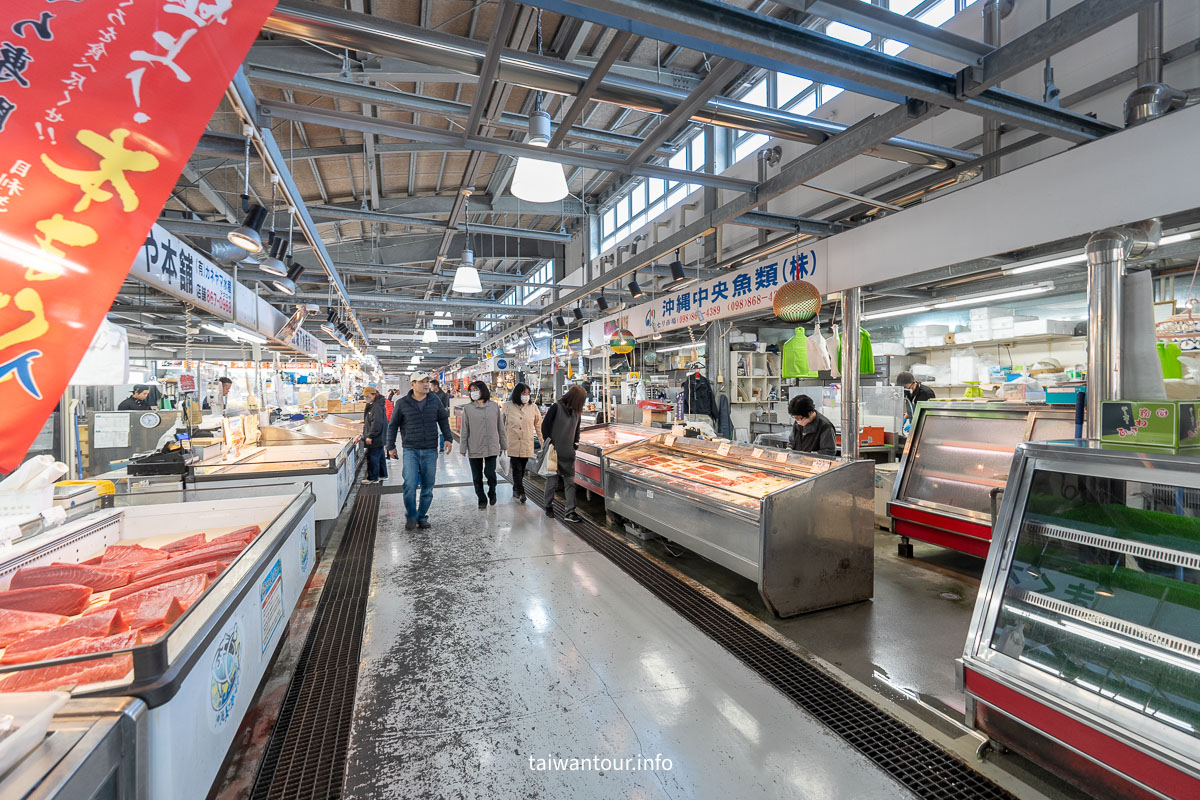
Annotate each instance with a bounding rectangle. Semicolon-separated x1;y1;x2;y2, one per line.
962;668;1200;798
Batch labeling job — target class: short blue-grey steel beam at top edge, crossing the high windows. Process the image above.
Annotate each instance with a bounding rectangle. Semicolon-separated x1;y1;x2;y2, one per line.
775;0;994;64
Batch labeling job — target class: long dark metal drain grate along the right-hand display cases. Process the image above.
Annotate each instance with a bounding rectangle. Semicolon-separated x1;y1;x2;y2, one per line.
526;481;1014;800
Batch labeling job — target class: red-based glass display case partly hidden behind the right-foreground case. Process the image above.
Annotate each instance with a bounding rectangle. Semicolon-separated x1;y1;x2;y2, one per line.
888;401;1075;558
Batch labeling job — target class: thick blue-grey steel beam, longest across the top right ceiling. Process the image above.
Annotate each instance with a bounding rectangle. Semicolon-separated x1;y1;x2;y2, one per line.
530;0;1113;142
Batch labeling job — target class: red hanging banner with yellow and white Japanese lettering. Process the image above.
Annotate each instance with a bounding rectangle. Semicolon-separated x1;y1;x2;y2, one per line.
0;0;275;471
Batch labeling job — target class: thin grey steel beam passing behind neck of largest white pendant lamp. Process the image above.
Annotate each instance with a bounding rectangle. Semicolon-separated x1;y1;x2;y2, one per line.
259;101;755;192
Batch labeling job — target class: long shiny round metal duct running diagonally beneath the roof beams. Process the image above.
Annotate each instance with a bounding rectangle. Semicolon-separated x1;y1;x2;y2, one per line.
263;0;974;169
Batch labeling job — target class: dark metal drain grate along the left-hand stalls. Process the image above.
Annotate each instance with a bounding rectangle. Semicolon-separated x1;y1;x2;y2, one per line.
250;492;379;800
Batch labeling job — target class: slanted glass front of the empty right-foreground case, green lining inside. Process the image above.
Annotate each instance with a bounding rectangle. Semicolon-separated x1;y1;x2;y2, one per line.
991;470;1200;738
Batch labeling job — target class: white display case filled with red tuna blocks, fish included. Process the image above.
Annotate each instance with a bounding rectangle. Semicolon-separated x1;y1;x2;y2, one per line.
0;485;317;800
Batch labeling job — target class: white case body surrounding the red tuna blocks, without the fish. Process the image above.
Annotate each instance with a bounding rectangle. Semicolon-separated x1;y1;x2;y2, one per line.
0;485;317;800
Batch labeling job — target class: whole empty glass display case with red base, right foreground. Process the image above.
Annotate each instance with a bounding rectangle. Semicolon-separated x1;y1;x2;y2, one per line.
960;441;1200;798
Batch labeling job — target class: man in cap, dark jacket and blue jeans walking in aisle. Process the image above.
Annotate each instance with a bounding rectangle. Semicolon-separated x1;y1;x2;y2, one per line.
388;369;454;530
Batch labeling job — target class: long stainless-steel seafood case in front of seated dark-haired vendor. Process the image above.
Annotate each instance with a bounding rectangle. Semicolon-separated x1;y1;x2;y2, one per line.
604;434;875;616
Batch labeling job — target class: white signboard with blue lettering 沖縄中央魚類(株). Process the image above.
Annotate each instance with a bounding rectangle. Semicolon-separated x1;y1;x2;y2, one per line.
584;241;829;348
